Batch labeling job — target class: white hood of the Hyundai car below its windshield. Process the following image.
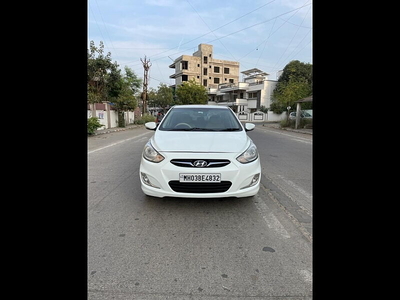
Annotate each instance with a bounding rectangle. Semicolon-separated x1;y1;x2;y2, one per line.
151;130;250;153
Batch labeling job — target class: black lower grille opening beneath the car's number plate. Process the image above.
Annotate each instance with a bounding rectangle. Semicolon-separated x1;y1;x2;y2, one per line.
168;180;232;194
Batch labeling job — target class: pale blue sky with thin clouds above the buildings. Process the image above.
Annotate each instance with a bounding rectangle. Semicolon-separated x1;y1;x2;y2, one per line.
87;0;313;89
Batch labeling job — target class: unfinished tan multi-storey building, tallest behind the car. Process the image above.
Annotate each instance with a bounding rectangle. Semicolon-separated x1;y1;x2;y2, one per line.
169;44;239;90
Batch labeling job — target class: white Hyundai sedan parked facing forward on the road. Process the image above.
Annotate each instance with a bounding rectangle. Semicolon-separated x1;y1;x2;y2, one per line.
140;105;261;198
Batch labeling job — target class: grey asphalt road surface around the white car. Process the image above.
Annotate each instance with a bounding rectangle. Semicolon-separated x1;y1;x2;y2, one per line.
88;126;312;300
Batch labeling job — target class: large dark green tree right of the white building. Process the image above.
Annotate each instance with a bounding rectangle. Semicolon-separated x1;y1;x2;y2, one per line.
270;60;312;113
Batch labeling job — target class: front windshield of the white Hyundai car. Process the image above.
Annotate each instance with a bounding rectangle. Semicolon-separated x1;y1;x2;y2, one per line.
159;107;242;131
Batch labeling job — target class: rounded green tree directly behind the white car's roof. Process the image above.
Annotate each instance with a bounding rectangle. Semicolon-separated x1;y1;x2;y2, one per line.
176;79;208;104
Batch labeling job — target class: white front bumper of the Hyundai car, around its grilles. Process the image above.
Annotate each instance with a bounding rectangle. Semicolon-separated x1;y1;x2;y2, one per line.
139;153;261;198
